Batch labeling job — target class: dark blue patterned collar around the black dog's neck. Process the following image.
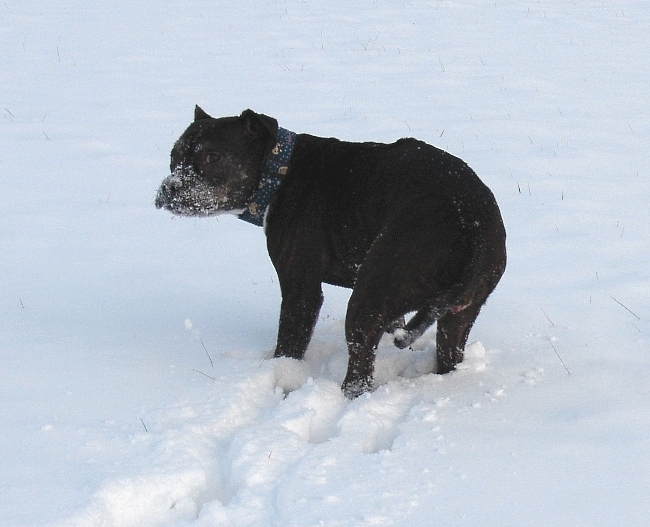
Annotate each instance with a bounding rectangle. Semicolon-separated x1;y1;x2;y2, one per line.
239;128;296;227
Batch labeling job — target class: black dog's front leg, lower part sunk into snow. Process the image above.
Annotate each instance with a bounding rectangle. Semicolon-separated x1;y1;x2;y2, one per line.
275;283;323;360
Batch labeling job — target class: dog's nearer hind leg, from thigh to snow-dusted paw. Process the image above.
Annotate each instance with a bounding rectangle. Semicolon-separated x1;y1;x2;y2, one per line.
343;221;466;398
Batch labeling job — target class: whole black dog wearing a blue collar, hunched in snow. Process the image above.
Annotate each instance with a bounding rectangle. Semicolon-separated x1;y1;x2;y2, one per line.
156;106;506;397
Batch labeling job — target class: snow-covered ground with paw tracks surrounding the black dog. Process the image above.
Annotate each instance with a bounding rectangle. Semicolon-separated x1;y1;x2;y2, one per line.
0;0;650;527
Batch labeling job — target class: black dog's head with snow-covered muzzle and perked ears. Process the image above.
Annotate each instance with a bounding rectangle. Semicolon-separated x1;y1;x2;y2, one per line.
156;106;278;216
